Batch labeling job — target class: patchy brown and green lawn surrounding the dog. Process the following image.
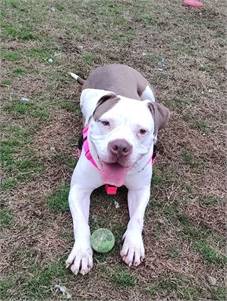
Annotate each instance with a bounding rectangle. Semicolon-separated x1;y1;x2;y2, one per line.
0;0;227;301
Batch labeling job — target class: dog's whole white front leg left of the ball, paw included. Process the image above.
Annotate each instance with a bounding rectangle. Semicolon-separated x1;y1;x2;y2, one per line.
66;185;93;275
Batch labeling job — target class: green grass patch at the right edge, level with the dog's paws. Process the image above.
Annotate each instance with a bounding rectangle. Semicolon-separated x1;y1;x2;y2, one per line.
193;240;227;266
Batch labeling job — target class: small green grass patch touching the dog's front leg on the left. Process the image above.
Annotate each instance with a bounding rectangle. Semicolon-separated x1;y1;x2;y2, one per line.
47;184;69;212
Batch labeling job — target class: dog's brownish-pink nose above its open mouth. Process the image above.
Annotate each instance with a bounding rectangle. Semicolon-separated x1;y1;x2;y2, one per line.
108;139;132;157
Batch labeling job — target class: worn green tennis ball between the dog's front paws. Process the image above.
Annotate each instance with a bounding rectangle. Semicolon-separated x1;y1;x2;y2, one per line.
91;228;115;253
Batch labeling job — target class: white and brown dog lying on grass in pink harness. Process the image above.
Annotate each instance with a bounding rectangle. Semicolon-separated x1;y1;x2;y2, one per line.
66;64;170;275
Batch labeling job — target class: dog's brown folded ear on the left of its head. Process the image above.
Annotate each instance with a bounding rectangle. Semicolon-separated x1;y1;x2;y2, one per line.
93;93;120;121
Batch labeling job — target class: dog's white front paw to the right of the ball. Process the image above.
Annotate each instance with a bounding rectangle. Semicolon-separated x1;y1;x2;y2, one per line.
121;230;145;266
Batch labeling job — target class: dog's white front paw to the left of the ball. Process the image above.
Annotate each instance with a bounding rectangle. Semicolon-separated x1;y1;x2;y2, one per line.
66;243;93;275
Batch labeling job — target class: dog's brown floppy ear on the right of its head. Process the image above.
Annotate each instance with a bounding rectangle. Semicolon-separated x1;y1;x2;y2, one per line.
148;102;170;135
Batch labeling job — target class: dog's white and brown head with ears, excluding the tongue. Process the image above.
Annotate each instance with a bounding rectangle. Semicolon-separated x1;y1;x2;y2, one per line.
89;94;169;173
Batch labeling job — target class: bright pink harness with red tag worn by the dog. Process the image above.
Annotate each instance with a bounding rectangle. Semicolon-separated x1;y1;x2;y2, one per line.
82;126;156;195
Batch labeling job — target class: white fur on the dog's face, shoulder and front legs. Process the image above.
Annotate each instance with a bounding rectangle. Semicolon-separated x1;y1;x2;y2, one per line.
66;85;157;274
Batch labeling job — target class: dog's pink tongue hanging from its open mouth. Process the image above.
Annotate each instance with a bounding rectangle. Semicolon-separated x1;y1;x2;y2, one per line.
101;162;129;187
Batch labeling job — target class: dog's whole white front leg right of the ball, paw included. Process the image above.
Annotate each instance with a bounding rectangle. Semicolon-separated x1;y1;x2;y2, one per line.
121;185;150;266
